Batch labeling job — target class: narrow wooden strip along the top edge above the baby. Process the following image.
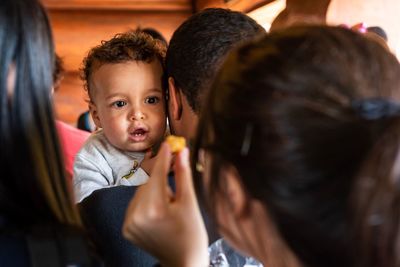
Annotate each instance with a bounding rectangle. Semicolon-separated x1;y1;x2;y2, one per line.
42;0;192;12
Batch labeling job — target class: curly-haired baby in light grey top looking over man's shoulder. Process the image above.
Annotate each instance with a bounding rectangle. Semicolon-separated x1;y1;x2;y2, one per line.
73;31;166;202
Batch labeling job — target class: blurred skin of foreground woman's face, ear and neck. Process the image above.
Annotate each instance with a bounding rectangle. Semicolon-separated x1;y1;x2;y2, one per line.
203;153;300;267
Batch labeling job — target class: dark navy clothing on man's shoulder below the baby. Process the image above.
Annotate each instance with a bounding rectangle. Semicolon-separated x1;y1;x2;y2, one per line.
78;186;156;267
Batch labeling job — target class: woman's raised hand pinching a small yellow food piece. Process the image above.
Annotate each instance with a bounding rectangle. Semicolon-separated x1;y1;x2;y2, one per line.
122;143;209;267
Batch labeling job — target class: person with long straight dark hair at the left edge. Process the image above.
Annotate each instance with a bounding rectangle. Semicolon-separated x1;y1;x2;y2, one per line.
0;0;98;266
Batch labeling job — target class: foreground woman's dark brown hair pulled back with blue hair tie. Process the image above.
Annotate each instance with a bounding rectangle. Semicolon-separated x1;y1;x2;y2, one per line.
193;26;400;267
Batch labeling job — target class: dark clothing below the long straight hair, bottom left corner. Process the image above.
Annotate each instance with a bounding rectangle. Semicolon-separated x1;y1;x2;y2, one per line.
0;217;103;267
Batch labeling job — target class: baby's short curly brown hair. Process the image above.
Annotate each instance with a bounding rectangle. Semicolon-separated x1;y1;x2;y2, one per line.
81;30;167;98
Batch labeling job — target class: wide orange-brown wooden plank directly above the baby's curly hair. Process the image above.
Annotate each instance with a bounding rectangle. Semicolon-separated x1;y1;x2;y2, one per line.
49;10;190;71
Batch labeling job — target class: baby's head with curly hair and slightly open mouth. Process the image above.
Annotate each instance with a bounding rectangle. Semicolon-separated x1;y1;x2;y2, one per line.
83;31;166;151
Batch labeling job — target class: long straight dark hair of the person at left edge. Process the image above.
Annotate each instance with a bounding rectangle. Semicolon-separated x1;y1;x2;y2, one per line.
0;0;80;227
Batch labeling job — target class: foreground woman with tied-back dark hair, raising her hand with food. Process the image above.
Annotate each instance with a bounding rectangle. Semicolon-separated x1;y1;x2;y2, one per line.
123;26;400;267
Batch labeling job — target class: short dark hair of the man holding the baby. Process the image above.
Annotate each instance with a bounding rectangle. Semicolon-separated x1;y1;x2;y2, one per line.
166;8;265;113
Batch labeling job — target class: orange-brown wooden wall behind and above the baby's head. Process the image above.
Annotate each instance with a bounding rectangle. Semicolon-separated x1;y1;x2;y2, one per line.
43;0;192;125
